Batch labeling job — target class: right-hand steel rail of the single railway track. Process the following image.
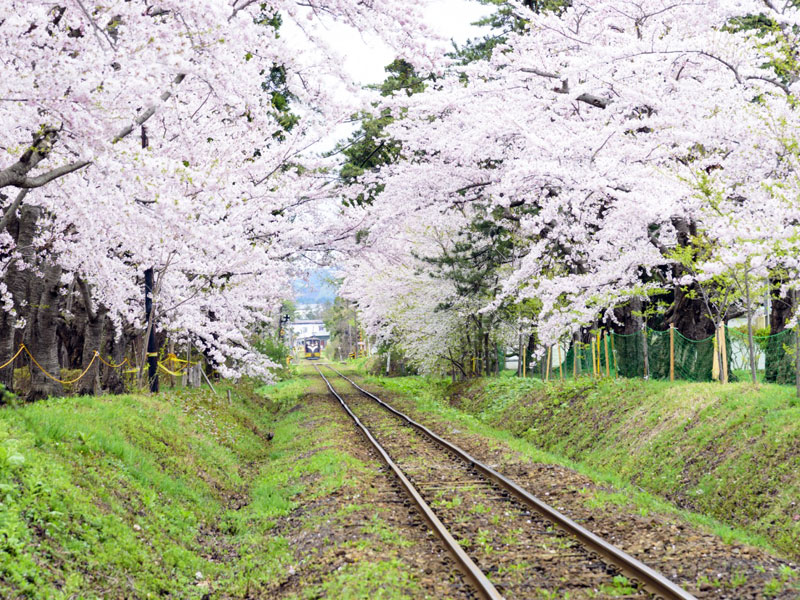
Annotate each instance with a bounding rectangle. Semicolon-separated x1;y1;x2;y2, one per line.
326;365;697;600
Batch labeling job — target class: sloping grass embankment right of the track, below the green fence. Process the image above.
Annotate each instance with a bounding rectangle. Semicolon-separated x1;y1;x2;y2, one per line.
364;377;800;559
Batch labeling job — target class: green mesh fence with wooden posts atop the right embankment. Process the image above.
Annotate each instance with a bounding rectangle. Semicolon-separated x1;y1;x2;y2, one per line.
529;327;796;383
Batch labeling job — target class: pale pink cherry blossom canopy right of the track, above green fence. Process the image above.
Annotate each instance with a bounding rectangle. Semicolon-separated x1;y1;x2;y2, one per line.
340;0;800;376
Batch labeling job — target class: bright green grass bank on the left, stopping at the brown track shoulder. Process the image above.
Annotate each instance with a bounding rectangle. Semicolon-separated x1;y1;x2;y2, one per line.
0;380;326;599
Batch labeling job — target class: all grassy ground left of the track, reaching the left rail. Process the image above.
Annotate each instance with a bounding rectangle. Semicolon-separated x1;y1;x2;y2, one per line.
0;367;446;600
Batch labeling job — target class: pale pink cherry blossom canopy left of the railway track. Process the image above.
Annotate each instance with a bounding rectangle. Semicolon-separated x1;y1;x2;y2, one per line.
0;0;434;397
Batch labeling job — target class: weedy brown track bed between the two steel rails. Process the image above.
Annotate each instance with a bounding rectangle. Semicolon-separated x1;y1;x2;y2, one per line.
316;370;693;599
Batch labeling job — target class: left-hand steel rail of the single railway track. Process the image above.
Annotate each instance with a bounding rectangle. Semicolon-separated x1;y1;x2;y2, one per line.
314;365;503;600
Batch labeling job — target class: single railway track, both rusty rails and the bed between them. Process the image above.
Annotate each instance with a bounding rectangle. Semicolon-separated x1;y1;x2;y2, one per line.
315;365;694;600
